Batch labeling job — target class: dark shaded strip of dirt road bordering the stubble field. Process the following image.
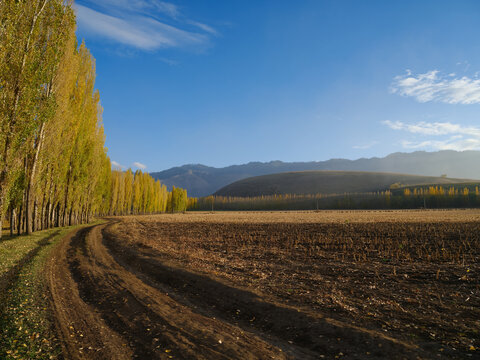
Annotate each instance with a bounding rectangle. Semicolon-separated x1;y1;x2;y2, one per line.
103;222;428;359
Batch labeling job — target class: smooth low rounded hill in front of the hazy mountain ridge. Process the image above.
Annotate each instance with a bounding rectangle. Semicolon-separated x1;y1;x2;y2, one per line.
215;171;472;197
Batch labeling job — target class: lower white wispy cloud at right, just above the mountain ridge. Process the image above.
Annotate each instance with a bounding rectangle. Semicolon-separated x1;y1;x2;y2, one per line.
383;120;480;151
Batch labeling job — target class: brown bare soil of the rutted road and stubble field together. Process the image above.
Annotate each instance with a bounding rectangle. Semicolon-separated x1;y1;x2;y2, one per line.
46;213;480;359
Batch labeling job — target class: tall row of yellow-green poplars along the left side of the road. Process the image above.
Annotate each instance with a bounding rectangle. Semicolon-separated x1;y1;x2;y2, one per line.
0;0;188;236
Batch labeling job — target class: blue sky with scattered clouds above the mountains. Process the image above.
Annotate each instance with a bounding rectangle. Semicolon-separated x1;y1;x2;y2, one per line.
75;0;480;172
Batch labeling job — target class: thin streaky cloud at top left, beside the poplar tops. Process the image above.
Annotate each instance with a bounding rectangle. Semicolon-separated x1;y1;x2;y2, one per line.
75;0;216;51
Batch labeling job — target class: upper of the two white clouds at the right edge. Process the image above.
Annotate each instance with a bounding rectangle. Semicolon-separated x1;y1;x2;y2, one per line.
390;70;480;104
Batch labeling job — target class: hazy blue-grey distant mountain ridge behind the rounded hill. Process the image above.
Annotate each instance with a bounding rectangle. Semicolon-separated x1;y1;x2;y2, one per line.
150;150;480;197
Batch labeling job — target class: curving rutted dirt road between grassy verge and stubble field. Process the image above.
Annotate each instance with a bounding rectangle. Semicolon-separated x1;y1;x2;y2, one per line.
46;221;442;359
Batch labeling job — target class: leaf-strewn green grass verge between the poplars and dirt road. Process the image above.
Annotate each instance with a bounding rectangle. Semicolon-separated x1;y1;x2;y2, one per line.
0;227;91;360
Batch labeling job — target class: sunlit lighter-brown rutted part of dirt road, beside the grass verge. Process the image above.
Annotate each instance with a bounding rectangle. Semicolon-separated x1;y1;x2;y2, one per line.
47;225;288;359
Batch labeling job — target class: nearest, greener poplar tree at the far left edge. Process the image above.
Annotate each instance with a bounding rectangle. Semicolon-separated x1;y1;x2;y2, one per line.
0;0;62;236
